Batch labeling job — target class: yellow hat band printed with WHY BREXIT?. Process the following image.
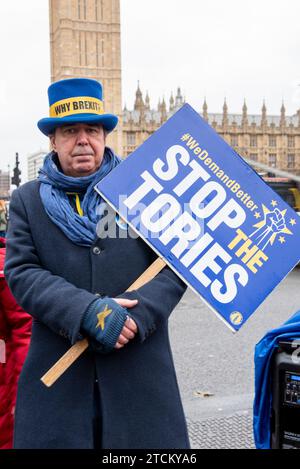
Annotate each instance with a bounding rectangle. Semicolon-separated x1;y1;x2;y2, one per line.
50;96;104;117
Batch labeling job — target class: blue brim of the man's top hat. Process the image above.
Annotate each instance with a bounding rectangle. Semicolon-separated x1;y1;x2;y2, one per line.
37;114;118;137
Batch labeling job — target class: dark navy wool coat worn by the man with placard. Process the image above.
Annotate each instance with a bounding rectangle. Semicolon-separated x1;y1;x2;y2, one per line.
5;181;189;449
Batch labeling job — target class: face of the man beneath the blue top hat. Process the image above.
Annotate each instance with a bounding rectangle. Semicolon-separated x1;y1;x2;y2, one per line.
50;124;105;177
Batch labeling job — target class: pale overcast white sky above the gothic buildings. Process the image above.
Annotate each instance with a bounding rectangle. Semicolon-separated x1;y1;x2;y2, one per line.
0;0;300;182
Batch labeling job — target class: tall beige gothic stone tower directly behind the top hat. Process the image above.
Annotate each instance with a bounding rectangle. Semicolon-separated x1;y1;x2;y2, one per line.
49;0;122;154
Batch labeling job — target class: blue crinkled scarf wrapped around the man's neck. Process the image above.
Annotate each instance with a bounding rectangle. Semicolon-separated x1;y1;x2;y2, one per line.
38;147;122;246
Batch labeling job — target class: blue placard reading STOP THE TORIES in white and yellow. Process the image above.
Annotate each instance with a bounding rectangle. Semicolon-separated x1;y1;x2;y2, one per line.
97;104;300;331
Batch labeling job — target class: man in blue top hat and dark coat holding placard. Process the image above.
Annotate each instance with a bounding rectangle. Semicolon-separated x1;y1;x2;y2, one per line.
5;79;189;449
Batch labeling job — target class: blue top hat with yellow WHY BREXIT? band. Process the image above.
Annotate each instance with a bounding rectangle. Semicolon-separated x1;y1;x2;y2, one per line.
37;78;118;136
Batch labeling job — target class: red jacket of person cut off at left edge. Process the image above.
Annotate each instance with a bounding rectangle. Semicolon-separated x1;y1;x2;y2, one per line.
0;238;31;449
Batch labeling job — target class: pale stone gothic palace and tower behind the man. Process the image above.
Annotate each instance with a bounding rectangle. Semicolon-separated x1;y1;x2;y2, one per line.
28;0;300;179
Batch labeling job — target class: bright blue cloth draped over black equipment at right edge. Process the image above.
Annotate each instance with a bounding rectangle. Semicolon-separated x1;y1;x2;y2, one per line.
253;311;300;449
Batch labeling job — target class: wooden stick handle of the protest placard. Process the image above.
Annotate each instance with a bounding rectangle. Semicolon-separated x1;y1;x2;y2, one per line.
41;257;166;388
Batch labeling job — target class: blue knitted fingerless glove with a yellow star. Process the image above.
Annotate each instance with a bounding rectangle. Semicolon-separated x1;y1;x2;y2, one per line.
81;298;127;353
